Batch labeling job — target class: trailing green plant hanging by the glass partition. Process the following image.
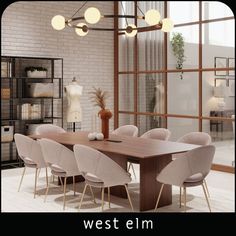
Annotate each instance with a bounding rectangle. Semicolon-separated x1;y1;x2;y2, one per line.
170;33;185;79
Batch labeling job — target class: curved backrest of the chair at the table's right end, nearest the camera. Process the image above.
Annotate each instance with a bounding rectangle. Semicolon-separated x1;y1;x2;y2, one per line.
157;145;215;186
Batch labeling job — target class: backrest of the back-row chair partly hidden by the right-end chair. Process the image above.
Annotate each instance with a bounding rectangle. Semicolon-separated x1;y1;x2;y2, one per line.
177;132;211;145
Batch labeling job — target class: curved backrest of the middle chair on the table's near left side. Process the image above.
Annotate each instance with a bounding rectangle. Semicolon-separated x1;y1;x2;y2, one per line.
39;138;79;176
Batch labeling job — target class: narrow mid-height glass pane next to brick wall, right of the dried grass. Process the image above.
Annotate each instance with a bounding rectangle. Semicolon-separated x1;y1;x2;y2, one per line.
119;75;134;111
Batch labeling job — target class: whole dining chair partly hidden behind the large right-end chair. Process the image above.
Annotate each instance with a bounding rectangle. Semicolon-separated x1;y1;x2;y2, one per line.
172;132;211;207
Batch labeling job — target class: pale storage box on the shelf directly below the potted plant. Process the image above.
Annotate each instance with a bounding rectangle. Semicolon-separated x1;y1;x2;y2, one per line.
27;83;54;98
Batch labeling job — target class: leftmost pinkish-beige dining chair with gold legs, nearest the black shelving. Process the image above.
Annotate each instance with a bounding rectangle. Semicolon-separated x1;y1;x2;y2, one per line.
14;133;48;198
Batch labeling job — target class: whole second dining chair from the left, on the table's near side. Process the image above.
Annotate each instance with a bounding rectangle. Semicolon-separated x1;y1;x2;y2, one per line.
39;138;80;210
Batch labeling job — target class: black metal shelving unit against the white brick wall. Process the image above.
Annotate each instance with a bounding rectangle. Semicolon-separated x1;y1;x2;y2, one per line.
1;56;63;169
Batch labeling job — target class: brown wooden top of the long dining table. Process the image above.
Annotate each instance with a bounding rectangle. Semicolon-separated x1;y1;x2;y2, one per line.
30;131;199;159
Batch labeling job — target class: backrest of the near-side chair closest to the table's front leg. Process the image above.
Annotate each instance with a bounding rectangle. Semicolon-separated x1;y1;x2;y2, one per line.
74;144;131;186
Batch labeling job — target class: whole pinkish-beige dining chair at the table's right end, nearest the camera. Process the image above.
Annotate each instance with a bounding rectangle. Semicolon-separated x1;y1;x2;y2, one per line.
155;145;215;212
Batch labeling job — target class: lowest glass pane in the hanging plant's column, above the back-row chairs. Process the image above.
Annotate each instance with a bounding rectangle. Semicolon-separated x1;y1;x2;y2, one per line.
167;117;198;141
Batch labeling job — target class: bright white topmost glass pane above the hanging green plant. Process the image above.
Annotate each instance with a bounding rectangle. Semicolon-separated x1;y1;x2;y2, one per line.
168;1;199;24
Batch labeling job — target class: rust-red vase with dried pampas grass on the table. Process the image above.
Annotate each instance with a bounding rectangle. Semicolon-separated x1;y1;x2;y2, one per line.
90;87;112;139
